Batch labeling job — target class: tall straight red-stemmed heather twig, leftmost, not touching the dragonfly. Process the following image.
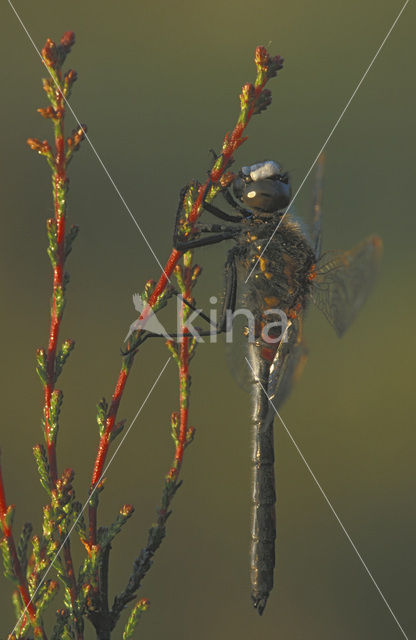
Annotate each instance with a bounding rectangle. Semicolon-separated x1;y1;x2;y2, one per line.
28;31;85;640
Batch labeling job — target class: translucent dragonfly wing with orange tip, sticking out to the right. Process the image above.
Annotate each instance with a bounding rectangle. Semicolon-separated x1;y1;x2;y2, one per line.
311;236;383;337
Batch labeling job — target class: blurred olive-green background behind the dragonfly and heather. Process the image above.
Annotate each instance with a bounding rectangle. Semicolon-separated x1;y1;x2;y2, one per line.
0;0;416;640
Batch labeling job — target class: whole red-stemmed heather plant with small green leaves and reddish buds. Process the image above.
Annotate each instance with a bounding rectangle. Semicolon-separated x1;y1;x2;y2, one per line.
0;31;283;640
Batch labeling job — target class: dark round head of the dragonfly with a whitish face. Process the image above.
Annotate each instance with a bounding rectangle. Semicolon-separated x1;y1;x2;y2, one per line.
233;160;291;215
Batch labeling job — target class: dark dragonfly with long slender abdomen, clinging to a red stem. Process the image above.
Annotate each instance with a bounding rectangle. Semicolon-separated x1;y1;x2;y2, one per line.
174;157;382;615
